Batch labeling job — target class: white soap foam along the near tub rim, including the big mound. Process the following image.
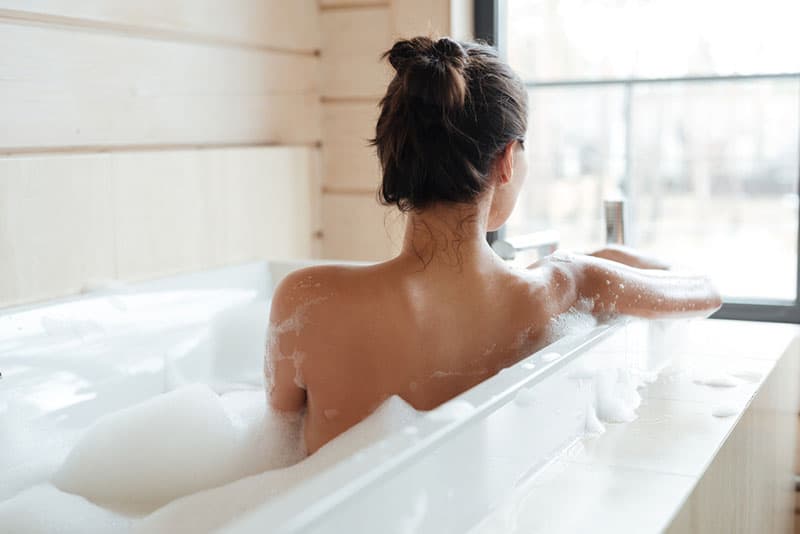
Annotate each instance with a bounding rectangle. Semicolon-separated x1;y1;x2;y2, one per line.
0;385;422;533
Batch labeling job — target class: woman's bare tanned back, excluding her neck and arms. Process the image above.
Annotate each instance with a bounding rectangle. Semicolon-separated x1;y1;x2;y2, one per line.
273;261;569;452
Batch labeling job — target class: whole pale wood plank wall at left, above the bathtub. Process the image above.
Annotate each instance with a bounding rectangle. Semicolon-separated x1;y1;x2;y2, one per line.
0;0;323;306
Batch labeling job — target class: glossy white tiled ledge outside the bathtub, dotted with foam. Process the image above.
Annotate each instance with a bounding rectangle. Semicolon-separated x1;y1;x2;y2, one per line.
472;321;800;533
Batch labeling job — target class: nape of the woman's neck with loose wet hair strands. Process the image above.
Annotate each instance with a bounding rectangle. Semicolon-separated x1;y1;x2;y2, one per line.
400;202;497;271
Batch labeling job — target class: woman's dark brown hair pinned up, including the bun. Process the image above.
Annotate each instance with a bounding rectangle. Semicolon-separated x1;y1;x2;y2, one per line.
371;37;527;211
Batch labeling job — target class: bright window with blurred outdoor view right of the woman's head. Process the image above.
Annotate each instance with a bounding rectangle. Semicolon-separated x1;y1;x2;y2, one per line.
506;0;800;301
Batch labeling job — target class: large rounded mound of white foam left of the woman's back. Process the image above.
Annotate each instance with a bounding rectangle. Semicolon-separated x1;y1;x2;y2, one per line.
53;384;301;513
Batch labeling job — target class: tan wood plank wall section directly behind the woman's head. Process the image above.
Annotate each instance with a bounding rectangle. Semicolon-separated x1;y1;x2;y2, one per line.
320;0;451;260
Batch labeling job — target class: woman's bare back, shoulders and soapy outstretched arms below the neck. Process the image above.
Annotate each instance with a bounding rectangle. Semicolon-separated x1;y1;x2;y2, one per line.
266;250;720;452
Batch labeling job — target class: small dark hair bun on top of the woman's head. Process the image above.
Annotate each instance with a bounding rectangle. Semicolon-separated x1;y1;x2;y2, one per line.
385;37;469;109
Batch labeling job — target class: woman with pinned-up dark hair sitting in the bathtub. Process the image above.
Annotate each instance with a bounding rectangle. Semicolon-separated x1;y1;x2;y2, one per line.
266;37;720;453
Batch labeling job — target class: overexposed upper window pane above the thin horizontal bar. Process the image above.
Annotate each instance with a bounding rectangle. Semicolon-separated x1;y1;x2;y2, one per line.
502;0;800;81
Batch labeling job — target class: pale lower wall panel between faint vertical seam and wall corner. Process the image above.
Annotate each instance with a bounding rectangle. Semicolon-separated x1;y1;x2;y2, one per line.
112;148;313;280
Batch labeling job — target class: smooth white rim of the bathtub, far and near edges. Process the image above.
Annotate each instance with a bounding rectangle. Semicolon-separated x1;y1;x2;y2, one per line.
0;259;627;532
